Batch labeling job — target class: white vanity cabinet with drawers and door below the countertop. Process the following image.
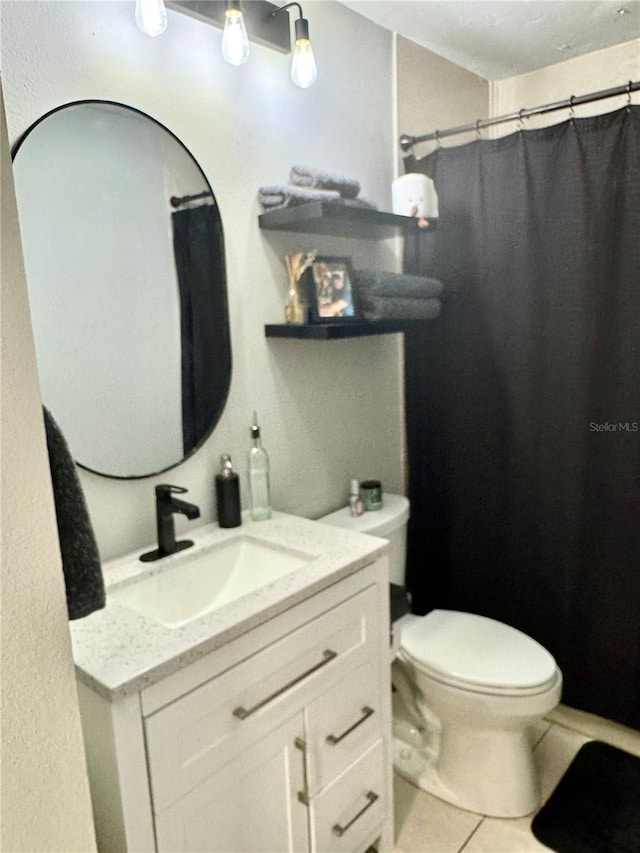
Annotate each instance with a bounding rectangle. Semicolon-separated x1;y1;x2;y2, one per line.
79;557;393;853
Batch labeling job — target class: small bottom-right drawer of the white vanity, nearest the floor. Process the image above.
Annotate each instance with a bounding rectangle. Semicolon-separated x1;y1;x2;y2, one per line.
311;741;387;853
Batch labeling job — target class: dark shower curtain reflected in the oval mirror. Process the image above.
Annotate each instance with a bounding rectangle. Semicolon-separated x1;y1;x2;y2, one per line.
171;204;231;455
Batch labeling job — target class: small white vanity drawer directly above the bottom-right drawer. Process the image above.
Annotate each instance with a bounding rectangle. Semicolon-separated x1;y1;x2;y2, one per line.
307;658;382;796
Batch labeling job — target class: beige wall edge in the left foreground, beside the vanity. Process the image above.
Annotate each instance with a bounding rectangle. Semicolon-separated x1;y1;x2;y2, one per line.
0;81;95;853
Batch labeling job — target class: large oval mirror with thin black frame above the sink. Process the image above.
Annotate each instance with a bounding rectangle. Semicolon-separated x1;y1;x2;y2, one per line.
14;101;231;478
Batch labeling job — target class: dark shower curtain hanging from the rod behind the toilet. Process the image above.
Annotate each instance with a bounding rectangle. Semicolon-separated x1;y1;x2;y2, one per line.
405;107;640;728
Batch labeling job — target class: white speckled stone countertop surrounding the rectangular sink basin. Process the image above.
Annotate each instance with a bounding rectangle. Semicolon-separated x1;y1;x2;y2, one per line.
70;513;389;701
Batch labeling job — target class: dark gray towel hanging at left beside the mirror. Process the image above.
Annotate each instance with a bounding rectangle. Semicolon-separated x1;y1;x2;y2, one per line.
43;406;106;619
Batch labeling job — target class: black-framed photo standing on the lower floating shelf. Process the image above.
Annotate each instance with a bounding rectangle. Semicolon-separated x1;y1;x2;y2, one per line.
305;257;356;323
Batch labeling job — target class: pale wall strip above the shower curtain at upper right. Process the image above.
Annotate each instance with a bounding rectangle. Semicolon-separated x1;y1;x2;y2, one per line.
491;39;640;125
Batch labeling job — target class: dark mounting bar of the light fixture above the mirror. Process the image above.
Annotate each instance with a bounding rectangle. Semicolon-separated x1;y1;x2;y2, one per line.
166;0;298;53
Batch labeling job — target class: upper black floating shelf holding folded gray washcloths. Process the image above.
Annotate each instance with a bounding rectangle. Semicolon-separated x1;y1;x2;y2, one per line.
258;201;438;240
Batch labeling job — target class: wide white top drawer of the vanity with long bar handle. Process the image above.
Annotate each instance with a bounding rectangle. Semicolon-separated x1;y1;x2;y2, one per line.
145;587;377;813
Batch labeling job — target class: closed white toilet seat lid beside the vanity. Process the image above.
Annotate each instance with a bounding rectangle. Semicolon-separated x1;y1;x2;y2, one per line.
400;610;559;696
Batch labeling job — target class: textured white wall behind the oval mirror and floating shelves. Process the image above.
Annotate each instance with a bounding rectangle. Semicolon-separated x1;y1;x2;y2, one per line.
1;0;403;559
